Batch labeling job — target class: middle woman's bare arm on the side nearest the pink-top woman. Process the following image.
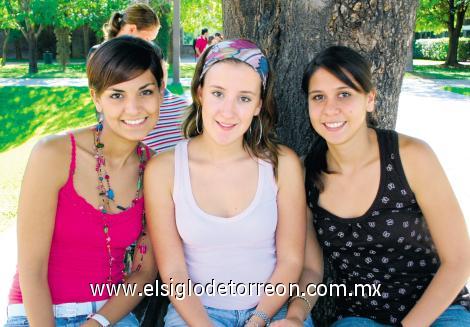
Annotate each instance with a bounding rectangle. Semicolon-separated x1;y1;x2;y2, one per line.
144;151;212;326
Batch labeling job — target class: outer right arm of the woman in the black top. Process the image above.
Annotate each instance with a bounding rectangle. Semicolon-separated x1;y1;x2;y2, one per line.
400;136;470;327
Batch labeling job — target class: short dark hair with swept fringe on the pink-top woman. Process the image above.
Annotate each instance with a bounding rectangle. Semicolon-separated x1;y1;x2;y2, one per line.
86;35;163;96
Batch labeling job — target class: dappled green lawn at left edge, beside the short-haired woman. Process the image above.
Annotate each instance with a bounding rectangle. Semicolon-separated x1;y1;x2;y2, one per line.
0;86;95;152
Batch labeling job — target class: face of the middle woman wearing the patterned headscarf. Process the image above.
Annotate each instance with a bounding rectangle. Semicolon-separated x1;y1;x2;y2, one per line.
197;61;262;144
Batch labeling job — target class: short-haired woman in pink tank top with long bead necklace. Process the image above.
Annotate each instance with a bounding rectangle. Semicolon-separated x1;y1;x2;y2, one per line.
6;36;165;326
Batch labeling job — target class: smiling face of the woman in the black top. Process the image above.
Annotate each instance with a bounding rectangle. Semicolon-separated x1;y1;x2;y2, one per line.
308;68;375;144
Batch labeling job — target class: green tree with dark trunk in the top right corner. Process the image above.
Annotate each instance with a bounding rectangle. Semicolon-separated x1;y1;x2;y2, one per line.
416;0;470;66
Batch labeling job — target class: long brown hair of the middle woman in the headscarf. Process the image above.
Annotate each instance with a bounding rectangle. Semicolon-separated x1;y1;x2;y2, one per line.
182;41;279;174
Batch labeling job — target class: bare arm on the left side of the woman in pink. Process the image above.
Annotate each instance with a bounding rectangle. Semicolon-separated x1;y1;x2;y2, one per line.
18;136;71;327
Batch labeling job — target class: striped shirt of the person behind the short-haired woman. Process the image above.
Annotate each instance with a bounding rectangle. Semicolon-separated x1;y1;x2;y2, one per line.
143;89;189;153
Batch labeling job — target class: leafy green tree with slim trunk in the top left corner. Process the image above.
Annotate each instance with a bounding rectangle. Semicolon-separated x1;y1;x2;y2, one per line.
5;0;57;74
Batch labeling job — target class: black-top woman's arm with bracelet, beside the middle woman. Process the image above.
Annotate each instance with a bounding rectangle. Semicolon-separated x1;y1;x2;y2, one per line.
271;210;323;327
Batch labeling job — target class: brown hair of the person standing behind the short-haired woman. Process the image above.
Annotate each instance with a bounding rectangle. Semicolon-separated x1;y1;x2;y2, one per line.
103;3;160;40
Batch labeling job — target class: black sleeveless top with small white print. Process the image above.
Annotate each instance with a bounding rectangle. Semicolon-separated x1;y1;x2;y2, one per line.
306;129;470;324
